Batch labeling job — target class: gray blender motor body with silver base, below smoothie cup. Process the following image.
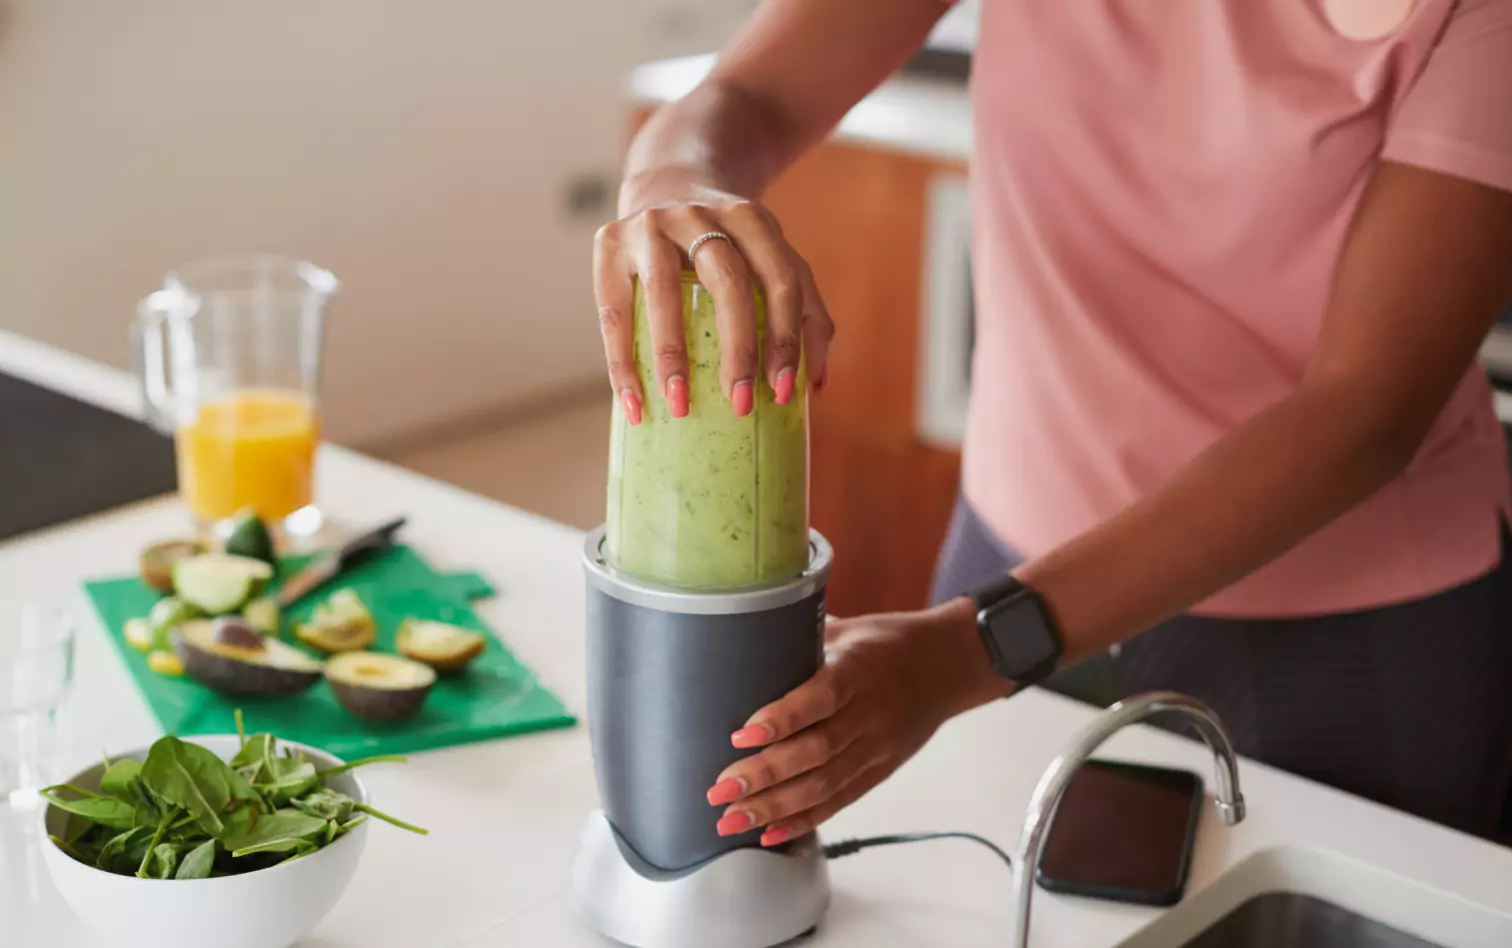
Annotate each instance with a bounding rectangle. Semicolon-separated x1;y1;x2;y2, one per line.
572;531;830;948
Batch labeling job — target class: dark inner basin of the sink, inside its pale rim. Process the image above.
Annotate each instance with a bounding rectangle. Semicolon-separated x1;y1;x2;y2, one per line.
1181;892;1444;948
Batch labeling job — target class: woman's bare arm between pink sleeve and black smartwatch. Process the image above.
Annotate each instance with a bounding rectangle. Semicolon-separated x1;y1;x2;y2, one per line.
1018;162;1512;662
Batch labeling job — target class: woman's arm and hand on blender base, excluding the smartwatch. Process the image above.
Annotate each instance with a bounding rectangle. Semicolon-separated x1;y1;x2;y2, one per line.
709;162;1512;845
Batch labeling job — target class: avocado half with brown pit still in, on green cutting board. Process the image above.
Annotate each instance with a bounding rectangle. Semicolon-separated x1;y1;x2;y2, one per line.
172;618;321;699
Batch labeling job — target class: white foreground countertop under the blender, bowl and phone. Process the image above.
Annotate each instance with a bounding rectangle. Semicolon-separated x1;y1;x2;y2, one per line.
0;333;1512;948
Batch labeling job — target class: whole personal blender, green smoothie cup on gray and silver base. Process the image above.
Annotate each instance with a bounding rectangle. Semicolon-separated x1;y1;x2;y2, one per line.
572;272;830;948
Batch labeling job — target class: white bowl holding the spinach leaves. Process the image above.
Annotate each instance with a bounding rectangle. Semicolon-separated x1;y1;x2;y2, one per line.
41;735;367;948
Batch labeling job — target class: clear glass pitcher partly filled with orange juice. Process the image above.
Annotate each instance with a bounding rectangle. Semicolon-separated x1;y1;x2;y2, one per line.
136;256;340;537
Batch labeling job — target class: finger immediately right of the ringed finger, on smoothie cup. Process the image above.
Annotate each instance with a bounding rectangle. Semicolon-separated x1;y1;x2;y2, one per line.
723;201;804;405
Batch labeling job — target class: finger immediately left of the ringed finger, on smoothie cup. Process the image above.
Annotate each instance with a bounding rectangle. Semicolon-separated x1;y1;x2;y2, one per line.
624;209;688;417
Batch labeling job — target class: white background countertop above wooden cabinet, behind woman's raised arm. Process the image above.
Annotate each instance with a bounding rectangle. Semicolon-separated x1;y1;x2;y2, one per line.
631;54;971;165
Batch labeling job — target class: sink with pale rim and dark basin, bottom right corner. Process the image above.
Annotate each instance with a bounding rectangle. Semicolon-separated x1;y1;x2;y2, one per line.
1119;847;1512;948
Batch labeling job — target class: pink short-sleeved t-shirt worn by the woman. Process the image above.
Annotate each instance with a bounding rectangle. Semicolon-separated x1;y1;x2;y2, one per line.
963;0;1512;617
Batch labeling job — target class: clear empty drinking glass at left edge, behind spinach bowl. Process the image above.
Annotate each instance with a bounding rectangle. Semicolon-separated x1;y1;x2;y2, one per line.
0;600;74;803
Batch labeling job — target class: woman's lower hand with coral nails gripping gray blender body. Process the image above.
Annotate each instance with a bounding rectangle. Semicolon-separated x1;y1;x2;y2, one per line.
709;599;1009;847
